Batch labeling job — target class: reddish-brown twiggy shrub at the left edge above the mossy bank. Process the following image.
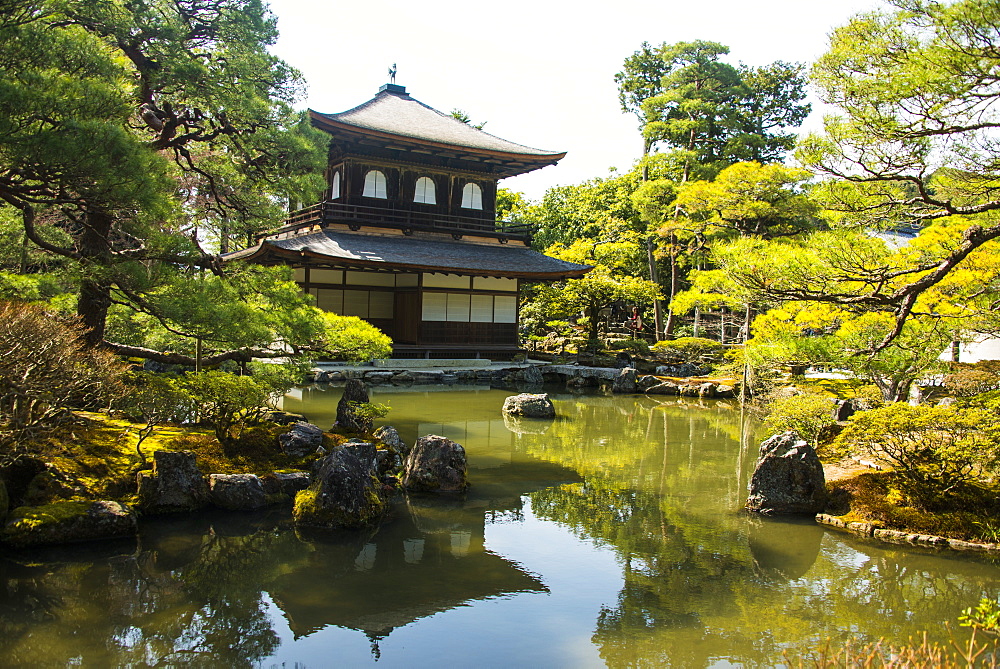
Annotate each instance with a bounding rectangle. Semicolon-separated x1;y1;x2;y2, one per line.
0;301;125;440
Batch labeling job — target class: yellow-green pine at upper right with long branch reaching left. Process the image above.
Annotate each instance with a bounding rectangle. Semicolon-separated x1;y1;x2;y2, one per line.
784;0;1000;347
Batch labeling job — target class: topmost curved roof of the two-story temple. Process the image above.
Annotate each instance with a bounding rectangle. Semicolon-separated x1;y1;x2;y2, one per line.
310;87;565;160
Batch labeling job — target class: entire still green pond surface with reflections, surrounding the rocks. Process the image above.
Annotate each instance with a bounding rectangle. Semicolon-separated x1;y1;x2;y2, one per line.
0;387;1000;668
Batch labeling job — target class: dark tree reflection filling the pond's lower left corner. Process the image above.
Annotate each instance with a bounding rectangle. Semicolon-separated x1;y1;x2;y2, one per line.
0;516;288;667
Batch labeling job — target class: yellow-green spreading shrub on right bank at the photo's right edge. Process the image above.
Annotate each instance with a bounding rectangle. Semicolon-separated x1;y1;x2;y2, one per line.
838;402;1000;508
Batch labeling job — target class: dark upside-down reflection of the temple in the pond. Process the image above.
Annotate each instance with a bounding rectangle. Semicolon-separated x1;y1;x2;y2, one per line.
268;396;580;640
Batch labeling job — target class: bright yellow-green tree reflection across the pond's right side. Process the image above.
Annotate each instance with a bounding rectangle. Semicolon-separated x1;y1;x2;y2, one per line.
517;398;1000;666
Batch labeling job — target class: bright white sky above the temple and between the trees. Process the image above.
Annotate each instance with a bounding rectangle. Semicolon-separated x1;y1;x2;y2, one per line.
270;0;884;200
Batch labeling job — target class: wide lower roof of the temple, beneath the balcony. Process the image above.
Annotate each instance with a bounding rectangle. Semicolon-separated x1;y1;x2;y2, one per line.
225;230;591;280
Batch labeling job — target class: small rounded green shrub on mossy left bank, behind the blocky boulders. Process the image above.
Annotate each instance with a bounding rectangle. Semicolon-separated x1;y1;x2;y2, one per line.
177;370;273;451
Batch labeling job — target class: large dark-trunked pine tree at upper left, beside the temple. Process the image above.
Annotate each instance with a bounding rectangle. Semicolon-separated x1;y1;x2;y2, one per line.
0;0;322;357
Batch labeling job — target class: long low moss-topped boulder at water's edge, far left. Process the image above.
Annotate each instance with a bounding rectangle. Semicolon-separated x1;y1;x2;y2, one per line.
3;500;137;548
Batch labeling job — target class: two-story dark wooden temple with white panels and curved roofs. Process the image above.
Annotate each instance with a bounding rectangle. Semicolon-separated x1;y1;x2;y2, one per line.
226;84;590;359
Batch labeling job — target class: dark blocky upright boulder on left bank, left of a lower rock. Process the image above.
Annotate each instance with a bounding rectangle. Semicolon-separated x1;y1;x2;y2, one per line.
137;451;209;514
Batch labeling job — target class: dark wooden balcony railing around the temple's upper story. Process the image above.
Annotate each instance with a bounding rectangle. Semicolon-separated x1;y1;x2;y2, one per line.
270;202;531;241
